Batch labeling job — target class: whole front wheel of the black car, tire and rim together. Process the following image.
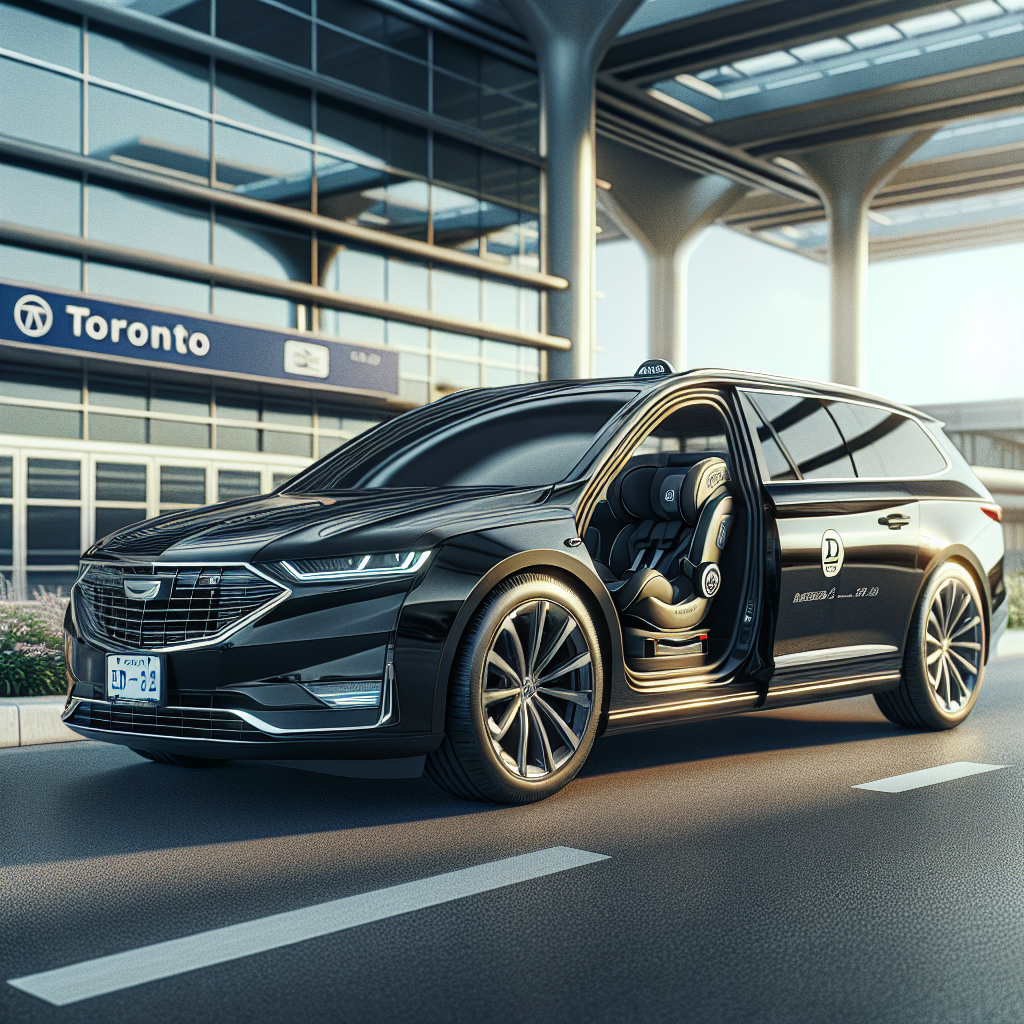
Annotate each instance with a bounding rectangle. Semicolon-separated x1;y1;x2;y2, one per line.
426;573;604;804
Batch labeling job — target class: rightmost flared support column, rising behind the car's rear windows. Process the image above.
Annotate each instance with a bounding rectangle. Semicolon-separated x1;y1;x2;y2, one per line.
791;131;932;387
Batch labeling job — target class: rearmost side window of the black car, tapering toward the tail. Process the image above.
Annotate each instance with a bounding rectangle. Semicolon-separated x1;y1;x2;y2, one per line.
828;401;946;477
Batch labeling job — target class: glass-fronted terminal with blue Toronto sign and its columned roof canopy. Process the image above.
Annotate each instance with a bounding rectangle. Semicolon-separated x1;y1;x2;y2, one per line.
0;0;1024;598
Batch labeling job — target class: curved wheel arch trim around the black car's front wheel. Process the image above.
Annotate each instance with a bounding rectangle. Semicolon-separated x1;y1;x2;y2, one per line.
433;549;626;734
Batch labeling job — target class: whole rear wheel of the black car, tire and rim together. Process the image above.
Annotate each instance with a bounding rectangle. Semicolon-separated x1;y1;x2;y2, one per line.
874;562;988;731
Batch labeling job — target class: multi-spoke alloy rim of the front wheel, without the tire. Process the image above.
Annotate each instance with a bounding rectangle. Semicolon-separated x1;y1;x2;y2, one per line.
480;600;594;781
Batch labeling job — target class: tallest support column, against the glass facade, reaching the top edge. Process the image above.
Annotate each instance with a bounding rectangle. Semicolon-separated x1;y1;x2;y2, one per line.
503;0;640;378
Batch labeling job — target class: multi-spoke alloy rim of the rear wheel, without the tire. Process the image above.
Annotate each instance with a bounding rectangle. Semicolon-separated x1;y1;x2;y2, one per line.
924;579;984;715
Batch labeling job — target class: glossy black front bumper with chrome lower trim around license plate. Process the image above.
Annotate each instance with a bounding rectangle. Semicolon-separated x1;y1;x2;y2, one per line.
63;565;442;760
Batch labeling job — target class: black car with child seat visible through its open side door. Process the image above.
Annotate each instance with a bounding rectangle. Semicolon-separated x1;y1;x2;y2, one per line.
65;360;1007;803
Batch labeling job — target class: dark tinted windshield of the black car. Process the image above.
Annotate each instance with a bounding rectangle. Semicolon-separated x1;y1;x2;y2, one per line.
287;389;637;492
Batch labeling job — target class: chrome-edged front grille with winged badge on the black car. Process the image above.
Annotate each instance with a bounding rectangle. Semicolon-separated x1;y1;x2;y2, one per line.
75;565;285;650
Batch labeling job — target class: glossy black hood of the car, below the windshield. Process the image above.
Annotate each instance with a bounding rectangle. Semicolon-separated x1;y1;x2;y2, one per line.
86;487;550;562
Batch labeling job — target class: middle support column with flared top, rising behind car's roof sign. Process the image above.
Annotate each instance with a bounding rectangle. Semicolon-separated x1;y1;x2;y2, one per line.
597;138;746;370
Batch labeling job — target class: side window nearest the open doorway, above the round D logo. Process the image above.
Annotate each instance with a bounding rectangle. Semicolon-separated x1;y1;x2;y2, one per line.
746;392;855;480
